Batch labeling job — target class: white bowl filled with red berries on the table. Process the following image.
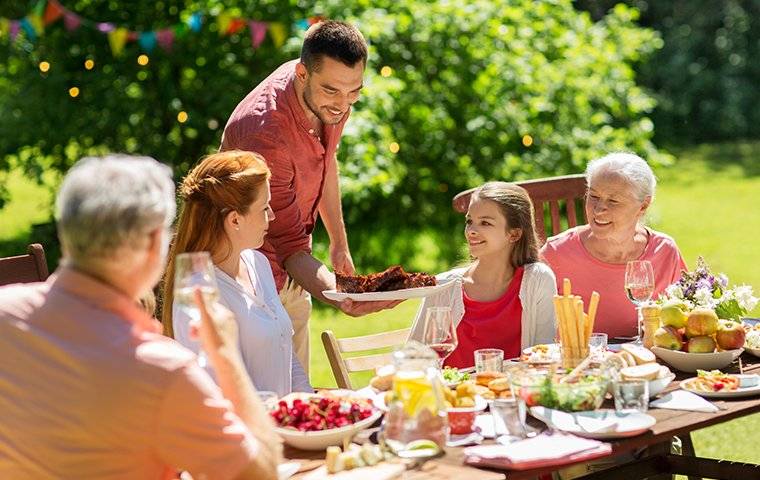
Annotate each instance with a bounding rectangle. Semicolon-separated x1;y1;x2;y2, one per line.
269;391;382;450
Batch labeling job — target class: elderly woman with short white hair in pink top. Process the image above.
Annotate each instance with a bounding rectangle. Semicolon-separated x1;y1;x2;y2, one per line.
541;153;686;337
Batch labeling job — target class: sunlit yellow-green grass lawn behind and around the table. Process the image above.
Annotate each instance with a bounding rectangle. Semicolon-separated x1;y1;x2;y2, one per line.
0;143;760;463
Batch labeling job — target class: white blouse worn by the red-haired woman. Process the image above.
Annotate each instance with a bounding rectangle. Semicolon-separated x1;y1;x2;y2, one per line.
172;250;313;396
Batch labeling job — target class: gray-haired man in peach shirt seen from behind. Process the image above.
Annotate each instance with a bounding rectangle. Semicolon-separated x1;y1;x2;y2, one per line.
0;155;281;479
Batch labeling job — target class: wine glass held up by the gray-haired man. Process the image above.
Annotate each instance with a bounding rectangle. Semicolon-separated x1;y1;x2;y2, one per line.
174;252;219;368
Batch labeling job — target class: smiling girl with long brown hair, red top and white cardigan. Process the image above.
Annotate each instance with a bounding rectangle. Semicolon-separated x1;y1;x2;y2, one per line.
410;182;557;367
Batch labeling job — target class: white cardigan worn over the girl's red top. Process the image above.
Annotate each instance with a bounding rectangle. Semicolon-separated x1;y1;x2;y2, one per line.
409;262;557;348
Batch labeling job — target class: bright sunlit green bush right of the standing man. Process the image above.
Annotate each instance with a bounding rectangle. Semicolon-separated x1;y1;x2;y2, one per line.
314;0;667;265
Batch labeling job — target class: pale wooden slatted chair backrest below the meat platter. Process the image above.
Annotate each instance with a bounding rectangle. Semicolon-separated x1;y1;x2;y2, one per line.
322;328;411;390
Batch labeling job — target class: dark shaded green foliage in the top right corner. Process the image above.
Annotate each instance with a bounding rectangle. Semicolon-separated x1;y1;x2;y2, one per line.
577;0;760;143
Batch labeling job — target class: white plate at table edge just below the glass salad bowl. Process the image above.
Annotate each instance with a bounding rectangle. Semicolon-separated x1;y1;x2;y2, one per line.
530;407;657;440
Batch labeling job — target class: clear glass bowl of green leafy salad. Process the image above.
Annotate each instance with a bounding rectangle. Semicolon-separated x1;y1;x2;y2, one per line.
511;367;609;412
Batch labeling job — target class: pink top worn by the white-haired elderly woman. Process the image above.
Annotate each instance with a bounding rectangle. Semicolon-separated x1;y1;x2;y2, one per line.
541;227;686;338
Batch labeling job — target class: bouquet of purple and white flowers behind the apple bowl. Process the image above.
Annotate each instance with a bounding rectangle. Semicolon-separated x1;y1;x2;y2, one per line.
658;257;758;322
